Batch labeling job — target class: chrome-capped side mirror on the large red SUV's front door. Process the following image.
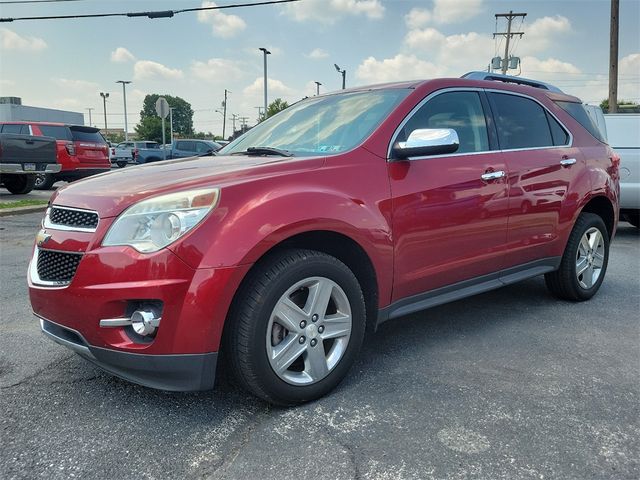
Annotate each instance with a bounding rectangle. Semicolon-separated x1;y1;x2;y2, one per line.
393;128;460;160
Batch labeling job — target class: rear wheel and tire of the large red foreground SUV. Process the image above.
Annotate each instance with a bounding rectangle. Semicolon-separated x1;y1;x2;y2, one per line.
544;213;609;302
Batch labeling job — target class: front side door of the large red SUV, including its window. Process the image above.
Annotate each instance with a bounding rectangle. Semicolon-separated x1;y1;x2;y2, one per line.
389;89;509;301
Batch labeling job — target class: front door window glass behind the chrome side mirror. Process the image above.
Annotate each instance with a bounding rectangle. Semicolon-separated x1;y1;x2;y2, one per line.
398;92;489;153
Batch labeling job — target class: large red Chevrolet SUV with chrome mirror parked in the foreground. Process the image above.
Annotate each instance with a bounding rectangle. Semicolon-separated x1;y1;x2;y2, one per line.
29;73;619;405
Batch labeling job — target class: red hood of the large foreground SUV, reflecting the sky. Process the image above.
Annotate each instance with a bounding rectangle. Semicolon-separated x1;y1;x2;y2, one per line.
51;155;324;218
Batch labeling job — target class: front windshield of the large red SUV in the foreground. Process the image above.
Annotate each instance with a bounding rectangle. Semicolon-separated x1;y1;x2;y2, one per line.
220;89;409;155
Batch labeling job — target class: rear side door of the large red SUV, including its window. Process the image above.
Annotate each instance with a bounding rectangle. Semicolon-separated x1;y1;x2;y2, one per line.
487;92;584;266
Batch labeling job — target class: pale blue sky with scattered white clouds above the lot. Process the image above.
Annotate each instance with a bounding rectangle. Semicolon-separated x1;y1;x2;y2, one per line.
0;0;640;134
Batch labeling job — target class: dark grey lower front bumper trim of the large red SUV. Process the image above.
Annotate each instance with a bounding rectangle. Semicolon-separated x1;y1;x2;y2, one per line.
40;317;218;392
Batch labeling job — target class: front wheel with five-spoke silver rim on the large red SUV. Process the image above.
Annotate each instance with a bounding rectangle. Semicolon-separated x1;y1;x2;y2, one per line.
223;250;366;406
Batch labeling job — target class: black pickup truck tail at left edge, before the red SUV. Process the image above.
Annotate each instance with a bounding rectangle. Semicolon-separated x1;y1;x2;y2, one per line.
0;133;61;194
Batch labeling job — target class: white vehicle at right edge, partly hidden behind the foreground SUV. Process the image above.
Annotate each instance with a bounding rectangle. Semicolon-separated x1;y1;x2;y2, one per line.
604;113;640;228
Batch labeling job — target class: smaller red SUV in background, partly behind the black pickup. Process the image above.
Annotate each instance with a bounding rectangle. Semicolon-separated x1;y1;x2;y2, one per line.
0;122;111;190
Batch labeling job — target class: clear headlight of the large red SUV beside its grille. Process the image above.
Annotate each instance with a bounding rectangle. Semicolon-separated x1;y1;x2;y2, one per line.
102;188;220;253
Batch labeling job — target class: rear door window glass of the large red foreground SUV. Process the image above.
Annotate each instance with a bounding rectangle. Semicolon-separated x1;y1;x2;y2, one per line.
489;93;554;150
